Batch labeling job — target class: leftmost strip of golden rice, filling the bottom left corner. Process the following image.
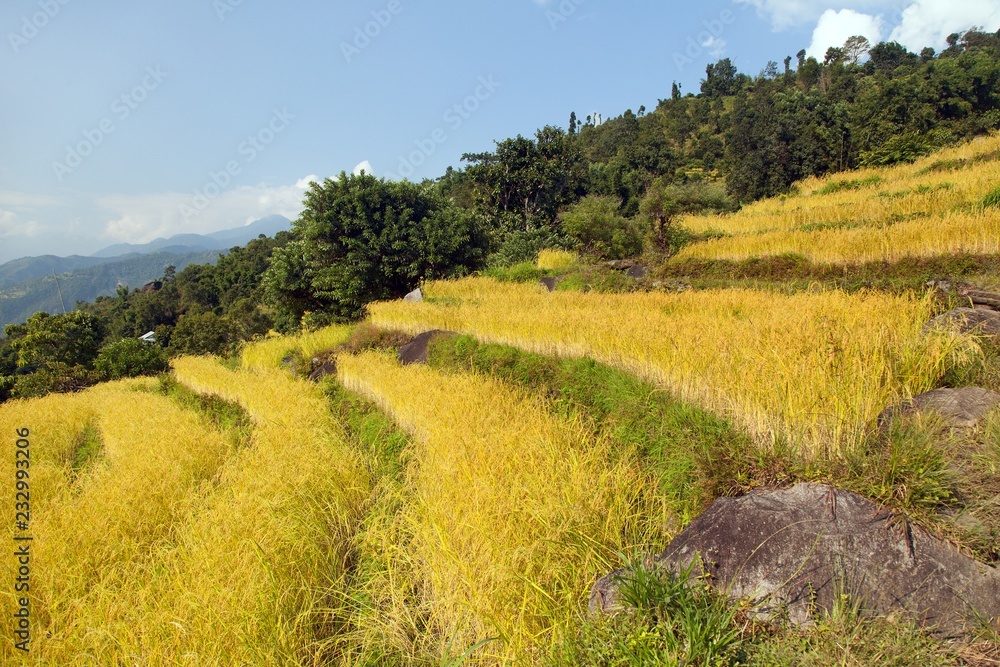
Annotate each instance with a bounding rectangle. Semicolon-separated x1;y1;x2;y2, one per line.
0;383;231;665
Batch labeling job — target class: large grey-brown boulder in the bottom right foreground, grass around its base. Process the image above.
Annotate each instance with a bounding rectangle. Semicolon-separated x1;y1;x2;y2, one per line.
590;484;1000;636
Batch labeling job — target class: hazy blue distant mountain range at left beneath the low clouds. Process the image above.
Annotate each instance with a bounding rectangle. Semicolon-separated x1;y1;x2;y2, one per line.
0;215;291;329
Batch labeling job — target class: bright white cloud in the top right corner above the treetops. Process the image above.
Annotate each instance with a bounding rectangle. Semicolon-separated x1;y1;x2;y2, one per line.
889;0;1000;51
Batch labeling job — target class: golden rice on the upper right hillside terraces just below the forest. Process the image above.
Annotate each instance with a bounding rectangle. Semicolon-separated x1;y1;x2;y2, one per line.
678;135;1000;263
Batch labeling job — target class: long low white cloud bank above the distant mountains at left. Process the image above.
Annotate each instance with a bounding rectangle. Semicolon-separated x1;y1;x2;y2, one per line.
97;176;317;243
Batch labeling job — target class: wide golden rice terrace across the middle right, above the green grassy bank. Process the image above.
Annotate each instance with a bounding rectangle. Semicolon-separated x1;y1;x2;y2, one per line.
369;278;959;460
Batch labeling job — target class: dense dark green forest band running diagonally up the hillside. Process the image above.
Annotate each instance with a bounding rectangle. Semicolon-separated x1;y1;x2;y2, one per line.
0;28;1000;400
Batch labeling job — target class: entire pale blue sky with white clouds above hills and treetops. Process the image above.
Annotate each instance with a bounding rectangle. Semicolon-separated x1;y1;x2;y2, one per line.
0;0;1000;263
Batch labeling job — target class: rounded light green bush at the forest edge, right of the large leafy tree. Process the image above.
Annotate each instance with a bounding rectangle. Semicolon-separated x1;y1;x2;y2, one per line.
560;195;642;259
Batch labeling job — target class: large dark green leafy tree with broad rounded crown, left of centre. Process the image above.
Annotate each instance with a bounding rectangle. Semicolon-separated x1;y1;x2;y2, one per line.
264;173;485;328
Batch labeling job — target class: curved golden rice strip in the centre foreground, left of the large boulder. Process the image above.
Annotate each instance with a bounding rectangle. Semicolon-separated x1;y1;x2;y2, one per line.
338;353;650;664
